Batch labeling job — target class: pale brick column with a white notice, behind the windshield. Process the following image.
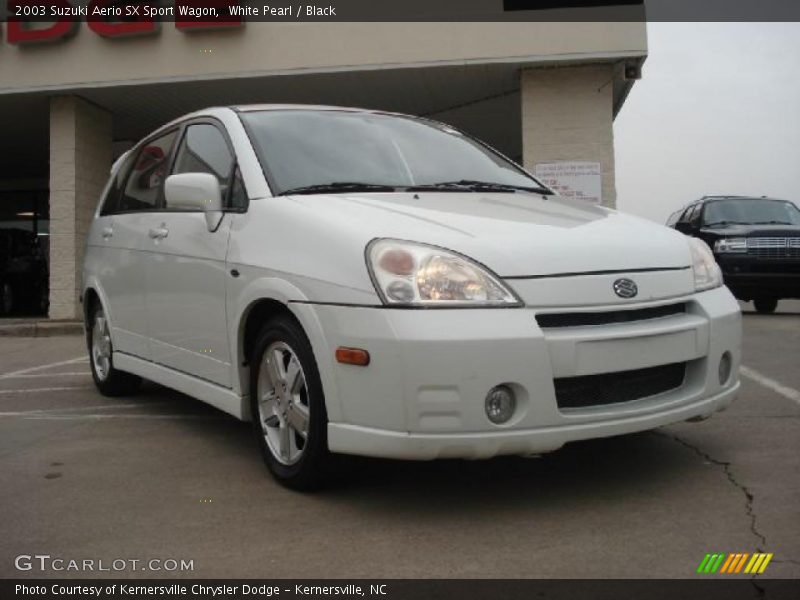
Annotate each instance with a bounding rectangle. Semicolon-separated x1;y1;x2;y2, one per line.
520;64;617;208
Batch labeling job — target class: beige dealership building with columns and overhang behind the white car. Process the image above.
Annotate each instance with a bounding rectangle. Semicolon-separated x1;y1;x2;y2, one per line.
0;17;647;319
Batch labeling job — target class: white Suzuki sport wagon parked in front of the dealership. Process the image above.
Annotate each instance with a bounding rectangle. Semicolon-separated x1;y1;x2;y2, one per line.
82;105;741;488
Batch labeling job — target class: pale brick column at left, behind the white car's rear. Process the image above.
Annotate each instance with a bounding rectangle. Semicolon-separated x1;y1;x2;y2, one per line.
50;96;112;319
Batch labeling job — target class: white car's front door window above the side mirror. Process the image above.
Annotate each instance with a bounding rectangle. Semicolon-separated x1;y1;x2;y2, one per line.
172;123;237;208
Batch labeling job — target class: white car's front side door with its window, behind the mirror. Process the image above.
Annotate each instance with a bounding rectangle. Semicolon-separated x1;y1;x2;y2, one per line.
146;120;242;387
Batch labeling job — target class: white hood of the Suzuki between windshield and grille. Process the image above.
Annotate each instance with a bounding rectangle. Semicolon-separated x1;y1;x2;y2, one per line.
290;192;691;277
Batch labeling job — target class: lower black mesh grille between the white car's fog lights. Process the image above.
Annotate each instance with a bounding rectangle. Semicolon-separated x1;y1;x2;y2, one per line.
553;362;686;408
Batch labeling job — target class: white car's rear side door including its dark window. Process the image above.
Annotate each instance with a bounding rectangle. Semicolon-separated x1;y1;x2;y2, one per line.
87;130;178;359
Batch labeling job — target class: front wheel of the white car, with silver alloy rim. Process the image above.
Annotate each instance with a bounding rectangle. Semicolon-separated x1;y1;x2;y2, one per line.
250;315;332;491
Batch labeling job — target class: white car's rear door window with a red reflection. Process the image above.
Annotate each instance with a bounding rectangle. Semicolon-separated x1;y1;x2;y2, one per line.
117;131;178;212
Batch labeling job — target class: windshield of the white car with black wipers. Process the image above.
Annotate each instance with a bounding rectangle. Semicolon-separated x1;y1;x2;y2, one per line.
241;109;550;195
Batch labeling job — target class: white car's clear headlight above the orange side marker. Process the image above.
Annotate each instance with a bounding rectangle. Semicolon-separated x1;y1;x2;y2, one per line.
367;239;522;307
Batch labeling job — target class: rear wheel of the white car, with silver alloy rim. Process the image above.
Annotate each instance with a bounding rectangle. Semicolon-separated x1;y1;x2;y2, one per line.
86;303;142;397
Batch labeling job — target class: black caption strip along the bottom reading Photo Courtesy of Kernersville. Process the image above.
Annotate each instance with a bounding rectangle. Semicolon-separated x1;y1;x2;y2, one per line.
0;576;800;600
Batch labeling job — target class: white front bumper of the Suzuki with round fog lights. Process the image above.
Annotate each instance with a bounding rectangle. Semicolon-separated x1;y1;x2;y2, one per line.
315;288;741;460
